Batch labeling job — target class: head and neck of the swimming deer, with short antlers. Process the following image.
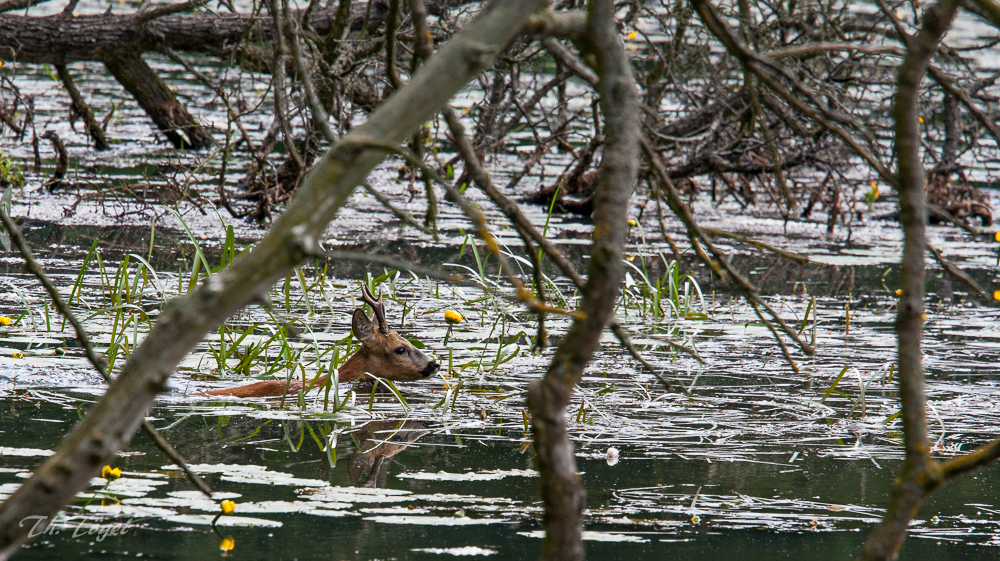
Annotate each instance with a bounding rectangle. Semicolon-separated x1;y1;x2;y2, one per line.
350;286;441;382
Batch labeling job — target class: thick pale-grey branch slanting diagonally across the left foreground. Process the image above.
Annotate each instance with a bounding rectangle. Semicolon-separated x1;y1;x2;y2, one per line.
0;0;544;561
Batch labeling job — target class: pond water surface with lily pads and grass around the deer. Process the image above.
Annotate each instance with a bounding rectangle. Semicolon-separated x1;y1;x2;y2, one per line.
0;2;1000;561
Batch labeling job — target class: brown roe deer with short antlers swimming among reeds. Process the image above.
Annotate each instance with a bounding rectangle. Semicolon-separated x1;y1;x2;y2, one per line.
197;286;441;397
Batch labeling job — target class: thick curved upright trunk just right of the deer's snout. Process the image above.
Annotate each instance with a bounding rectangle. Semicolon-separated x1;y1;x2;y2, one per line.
528;0;640;560
